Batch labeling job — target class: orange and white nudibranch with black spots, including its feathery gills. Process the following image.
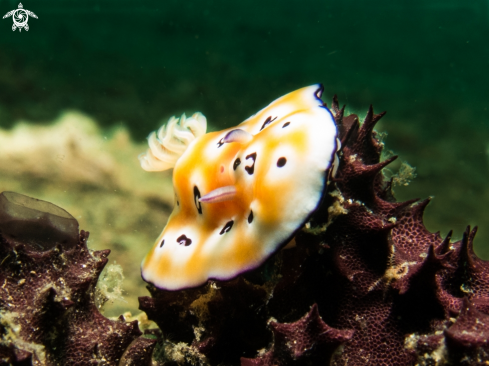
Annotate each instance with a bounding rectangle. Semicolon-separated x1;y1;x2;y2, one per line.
139;85;339;290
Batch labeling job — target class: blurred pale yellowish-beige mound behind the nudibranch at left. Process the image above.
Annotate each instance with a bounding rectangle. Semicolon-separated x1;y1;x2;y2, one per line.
0;111;173;316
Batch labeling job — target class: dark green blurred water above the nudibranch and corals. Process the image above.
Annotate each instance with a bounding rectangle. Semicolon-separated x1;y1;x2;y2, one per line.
0;0;489;262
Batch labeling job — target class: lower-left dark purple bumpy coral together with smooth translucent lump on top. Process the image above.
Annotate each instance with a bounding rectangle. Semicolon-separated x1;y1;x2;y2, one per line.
0;192;155;366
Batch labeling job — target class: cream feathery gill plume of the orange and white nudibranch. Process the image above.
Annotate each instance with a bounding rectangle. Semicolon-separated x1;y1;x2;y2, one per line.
139;112;207;171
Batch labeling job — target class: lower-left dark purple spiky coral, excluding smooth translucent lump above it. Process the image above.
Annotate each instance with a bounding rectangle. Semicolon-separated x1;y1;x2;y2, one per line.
0;226;155;366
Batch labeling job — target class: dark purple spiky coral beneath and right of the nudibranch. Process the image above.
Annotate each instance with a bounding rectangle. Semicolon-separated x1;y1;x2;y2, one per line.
140;98;489;366
